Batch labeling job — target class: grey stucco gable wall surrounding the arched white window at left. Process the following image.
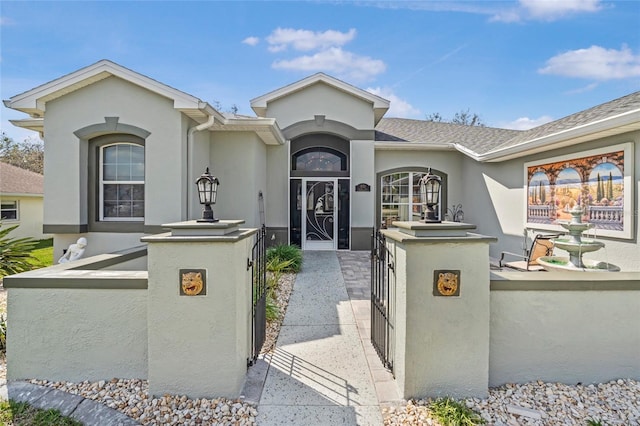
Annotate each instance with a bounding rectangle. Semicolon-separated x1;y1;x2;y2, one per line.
44;77;186;230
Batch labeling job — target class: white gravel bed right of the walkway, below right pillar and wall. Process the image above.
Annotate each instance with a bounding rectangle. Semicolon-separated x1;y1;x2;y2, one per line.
383;379;640;426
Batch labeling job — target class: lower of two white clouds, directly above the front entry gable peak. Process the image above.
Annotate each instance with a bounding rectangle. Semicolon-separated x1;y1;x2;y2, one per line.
272;47;387;81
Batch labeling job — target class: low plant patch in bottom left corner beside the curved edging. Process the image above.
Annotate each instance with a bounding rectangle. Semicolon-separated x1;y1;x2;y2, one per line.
0;400;82;426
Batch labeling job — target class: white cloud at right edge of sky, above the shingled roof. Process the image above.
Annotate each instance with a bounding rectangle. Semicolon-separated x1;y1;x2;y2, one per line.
538;46;640;80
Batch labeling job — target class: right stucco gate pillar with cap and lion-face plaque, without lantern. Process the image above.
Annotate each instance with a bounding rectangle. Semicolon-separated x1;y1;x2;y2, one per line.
382;222;496;399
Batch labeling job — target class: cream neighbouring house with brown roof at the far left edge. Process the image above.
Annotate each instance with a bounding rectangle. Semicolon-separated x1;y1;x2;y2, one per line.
0;162;50;240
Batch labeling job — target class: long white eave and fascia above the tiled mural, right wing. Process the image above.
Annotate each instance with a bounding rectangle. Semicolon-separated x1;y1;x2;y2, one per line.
470;109;640;162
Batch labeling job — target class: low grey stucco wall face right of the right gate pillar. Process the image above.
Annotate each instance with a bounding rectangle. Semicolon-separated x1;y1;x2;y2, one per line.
489;282;640;386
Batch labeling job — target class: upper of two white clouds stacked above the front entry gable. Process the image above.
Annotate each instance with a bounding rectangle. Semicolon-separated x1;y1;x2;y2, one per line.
267;28;356;52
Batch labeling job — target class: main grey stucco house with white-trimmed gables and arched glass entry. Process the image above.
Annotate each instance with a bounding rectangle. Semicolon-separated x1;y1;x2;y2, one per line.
5;60;640;270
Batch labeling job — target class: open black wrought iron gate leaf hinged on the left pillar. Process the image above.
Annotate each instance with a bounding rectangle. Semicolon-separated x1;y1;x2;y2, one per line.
247;225;267;366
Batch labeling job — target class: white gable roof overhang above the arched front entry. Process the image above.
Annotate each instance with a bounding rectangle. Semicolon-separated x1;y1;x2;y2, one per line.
251;73;389;124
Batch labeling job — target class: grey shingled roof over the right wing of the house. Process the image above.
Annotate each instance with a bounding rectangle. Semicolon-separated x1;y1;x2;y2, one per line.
375;92;640;156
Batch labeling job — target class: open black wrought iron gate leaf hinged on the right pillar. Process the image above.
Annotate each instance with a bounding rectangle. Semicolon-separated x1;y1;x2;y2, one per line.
371;230;396;373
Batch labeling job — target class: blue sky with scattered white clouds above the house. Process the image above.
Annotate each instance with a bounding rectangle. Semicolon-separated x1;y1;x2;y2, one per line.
0;0;640;140
